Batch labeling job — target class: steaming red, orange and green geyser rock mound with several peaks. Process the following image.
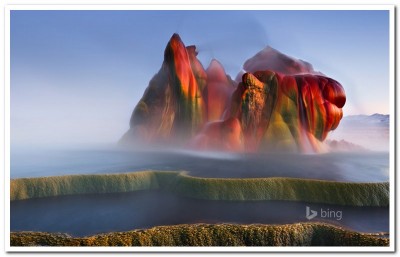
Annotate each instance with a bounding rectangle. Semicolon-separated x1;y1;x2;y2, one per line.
120;34;346;152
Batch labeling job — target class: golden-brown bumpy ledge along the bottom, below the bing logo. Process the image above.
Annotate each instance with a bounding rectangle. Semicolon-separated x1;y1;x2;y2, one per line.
11;223;389;246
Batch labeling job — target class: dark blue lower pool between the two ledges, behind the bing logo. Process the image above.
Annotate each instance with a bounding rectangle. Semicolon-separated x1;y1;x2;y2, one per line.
11;191;389;236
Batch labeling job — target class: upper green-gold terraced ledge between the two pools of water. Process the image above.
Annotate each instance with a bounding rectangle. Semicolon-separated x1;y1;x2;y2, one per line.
10;171;389;206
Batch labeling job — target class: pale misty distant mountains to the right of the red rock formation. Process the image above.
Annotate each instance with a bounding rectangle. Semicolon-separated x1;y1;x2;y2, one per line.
327;113;390;151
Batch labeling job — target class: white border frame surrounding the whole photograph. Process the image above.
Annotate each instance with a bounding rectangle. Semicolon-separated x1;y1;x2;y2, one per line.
4;4;396;252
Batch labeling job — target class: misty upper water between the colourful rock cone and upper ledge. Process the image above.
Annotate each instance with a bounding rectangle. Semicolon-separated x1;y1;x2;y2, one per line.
11;146;389;182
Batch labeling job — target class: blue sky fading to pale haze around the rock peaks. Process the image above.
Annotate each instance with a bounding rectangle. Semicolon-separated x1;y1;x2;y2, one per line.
10;10;390;146
